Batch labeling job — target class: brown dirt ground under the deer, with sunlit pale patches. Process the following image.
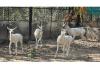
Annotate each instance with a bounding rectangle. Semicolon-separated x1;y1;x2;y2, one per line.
0;40;100;62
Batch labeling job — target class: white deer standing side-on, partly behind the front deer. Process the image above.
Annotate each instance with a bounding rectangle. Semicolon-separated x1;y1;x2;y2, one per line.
63;24;86;40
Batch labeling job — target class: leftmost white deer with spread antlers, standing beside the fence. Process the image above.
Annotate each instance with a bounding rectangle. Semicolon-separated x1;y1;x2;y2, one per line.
7;27;23;55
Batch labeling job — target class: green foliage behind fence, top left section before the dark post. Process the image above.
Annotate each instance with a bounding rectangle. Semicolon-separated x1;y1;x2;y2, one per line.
0;7;29;21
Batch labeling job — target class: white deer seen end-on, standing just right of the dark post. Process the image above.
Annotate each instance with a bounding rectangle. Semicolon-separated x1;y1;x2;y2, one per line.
34;25;43;49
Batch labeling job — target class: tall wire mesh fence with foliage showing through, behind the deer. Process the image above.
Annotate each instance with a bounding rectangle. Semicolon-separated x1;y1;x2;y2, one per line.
0;7;100;41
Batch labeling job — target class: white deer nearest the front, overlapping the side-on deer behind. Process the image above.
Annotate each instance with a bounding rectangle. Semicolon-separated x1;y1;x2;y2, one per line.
55;29;74;57
